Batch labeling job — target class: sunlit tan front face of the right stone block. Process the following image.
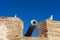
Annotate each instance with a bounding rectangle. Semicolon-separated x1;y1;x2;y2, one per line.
47;20;60;40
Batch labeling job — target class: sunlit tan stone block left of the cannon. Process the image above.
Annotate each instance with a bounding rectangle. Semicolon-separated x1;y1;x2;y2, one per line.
0;17;23;40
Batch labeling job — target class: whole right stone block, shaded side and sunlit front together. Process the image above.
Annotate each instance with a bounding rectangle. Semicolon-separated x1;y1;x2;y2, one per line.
37;19;60;40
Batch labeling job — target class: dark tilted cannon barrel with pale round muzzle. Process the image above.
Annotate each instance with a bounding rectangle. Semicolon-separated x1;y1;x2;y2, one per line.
25;20;38;37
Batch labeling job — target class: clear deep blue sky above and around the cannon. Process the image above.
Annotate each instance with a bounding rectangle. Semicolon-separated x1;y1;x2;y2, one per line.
0;0;60;36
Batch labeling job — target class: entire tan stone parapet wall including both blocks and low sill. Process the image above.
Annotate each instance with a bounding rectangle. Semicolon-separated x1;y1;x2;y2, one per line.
0;17;60;40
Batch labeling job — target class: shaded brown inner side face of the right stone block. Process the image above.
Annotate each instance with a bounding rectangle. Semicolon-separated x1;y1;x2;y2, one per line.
37;21;48;37
